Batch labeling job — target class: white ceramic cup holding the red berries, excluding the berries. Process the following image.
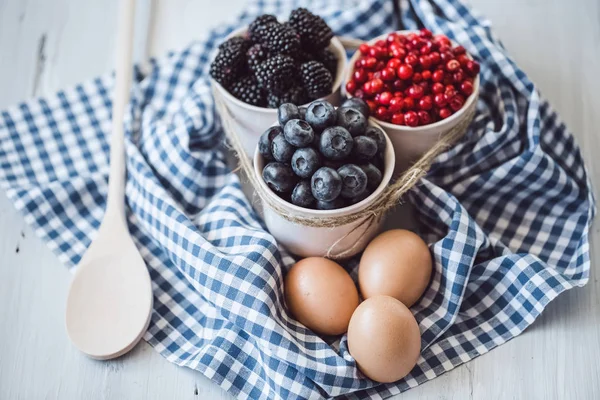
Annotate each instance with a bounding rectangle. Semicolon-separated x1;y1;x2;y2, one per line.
344;31;479;172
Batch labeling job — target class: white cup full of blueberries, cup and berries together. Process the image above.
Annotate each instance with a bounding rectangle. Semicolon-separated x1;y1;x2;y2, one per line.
254;98;395;258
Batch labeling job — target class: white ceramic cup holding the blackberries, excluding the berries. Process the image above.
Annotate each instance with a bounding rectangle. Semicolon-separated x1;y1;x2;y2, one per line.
213;27;347;157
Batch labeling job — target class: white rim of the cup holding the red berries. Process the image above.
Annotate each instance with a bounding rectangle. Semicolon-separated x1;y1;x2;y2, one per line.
342;29;480;132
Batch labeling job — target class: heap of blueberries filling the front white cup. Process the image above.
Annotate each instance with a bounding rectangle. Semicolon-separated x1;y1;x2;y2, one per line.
258;98;386;210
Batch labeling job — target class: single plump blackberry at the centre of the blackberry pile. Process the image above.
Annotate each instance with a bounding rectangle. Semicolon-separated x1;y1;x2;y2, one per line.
254;54;296;94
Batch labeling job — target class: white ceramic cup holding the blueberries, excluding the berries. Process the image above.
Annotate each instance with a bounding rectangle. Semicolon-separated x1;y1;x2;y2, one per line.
254;121;395;258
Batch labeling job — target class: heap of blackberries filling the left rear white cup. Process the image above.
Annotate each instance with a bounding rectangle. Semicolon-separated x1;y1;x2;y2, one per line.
210;8;338;108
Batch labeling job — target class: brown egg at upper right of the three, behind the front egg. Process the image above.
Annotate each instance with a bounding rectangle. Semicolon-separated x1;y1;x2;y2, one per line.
358;229;432;307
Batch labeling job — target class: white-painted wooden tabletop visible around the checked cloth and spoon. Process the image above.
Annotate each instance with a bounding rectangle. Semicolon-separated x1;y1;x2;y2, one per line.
0;0;600;399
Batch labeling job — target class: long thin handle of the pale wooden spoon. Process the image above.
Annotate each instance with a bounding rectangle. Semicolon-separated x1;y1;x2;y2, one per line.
105;0;135;223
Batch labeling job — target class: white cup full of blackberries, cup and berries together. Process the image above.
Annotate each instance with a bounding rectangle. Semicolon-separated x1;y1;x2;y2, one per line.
210;8;346;157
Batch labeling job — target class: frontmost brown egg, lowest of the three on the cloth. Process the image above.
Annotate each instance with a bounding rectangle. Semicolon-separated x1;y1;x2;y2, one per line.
348;296;421;383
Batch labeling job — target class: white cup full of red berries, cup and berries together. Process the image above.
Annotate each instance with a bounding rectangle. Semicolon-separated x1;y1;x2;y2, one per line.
344;29;480;170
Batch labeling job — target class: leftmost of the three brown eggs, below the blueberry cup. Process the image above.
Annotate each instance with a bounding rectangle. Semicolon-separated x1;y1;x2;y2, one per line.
285;257;358;335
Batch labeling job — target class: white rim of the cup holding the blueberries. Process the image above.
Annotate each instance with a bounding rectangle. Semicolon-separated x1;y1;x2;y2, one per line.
252;119;396;217
